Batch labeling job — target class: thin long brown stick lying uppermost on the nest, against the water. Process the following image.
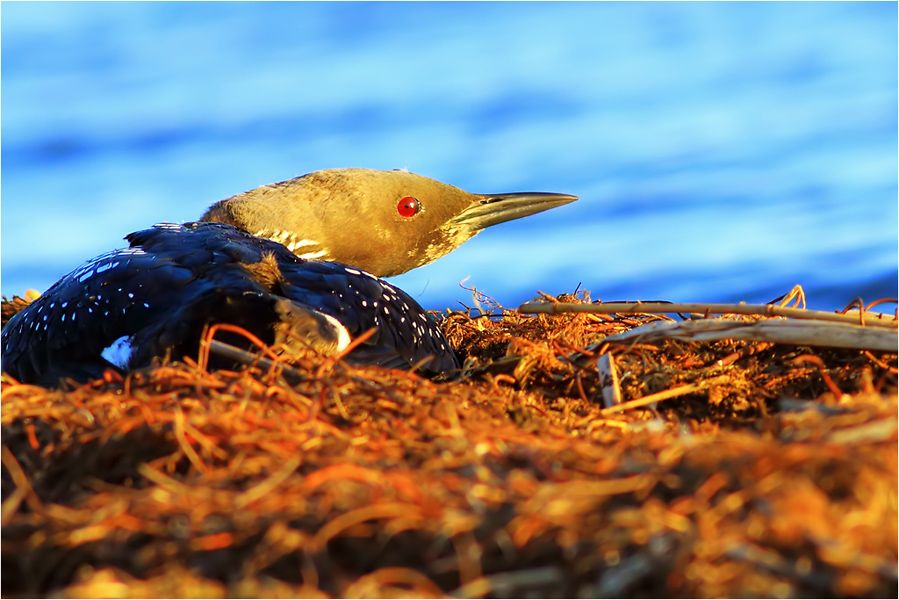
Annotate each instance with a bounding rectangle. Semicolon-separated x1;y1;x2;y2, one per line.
518;302;899;329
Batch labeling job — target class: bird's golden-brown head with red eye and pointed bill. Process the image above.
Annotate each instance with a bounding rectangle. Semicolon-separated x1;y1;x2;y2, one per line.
202;169;577;276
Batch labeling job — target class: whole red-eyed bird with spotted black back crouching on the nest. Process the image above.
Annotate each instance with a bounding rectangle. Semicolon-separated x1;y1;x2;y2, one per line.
0;169;577;386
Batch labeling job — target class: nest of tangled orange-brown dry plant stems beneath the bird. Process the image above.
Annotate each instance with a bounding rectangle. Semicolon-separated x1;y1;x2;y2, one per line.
2;295;897;598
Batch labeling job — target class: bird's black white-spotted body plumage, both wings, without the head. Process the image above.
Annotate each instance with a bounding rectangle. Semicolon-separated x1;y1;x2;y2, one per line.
2;223;458;384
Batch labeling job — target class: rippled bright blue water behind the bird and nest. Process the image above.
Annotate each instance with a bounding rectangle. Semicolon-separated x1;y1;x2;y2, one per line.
0;2;899;308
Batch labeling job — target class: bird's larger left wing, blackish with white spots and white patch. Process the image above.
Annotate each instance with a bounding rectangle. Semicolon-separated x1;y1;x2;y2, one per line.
0;224;292;384
